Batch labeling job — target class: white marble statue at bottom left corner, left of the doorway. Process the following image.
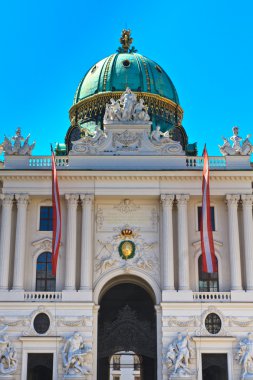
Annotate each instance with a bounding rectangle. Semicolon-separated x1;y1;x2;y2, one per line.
0;326;18;375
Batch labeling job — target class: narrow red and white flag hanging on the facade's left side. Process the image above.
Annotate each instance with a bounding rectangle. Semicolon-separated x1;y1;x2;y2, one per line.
51;147;61;276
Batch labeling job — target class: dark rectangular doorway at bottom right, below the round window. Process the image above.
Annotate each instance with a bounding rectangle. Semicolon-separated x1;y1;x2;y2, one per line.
202;354;228;380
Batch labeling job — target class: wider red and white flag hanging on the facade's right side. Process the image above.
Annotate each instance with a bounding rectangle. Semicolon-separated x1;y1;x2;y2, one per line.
200;146;217;273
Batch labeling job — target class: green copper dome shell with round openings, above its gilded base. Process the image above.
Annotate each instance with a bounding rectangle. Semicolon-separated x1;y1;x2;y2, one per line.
74;52;179;104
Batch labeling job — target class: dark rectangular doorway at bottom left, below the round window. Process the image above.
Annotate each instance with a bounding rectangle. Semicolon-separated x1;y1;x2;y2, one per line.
27;353;53;380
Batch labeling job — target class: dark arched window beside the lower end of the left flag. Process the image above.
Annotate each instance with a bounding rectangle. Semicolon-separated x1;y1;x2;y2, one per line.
36;252;55;292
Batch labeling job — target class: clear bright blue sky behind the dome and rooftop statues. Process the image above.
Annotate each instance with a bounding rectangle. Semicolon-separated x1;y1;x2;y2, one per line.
0;0;253;155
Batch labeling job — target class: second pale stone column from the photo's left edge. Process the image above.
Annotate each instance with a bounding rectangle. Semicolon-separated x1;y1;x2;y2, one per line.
13;194;29;290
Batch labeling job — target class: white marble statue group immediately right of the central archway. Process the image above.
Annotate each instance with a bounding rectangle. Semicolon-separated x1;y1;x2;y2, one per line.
165;332;192;379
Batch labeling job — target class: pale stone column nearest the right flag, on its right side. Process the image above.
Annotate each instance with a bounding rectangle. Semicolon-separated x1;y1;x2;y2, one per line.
226;194;242;290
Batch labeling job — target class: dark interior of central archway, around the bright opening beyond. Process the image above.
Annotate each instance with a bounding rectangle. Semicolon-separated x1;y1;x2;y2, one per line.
98;282;157;380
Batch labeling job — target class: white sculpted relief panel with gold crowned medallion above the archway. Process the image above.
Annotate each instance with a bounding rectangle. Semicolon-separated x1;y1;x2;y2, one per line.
94;199;159;278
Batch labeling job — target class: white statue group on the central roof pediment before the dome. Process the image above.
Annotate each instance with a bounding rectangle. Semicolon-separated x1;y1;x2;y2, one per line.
104;87;150;123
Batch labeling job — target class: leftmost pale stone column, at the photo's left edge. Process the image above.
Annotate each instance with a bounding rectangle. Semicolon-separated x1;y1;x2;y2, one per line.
0;194;13;290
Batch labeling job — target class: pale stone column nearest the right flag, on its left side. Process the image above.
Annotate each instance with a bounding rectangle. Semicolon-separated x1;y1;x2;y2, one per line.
177;194;190;290
